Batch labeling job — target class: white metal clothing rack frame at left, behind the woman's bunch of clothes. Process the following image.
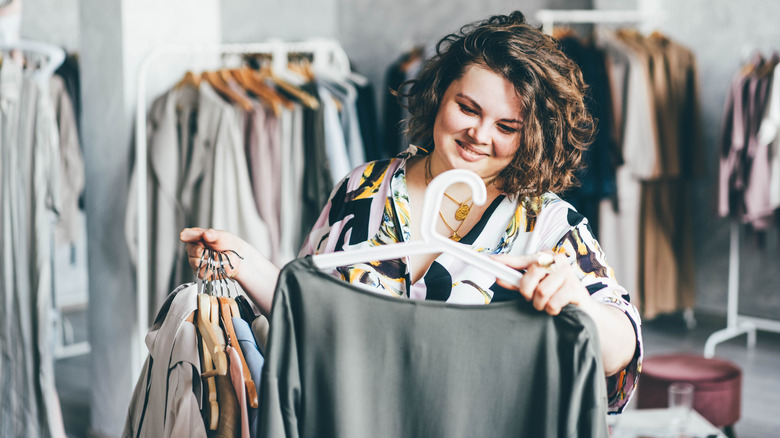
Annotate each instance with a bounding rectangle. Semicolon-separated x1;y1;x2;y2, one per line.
131;38;350;375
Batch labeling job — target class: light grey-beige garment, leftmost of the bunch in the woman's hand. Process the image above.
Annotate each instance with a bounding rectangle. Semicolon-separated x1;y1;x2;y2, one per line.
122;283;206;438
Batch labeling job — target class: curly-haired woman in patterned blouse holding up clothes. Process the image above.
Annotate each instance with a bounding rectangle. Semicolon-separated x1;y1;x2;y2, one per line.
181;12;641;412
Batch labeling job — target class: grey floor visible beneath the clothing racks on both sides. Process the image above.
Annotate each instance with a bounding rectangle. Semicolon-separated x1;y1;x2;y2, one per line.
56;315;780;438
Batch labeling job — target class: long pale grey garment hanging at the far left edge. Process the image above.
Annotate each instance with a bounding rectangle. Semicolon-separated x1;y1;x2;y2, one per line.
0;58;65;437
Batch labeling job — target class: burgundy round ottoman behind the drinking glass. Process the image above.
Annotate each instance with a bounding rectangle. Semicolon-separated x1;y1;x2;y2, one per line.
637;354;742;427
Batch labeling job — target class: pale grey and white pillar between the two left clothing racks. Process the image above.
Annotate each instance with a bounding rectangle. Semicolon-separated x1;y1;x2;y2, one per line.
80;0;221;436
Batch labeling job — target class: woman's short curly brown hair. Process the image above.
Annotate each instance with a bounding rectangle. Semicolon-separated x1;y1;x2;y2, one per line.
396;11;596;197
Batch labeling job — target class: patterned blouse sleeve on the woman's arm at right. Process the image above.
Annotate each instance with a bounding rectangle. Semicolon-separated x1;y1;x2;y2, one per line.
554;216;643;414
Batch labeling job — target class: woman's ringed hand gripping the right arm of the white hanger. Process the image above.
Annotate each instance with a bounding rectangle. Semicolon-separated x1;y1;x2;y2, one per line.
493;252;593;315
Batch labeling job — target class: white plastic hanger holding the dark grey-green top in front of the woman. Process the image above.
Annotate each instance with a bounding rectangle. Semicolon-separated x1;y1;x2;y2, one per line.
312;169;523;284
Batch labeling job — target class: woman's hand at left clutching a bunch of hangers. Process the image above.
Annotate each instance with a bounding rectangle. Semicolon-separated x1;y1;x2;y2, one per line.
179;227;249;280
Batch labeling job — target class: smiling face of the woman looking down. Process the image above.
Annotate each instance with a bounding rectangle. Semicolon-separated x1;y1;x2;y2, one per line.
432;65;521;179
